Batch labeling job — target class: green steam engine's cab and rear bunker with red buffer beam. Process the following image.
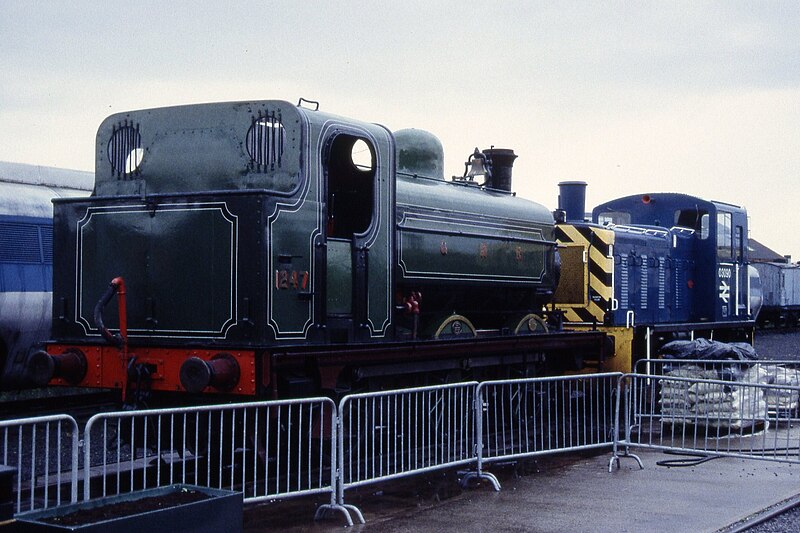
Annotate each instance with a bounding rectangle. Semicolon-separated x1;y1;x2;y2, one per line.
28;101;394;395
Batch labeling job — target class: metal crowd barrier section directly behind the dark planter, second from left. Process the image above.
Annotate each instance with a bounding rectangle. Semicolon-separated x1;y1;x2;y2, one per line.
84;398;352;524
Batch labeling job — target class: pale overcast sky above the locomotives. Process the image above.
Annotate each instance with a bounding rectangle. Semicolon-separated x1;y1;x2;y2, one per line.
0;0;800;260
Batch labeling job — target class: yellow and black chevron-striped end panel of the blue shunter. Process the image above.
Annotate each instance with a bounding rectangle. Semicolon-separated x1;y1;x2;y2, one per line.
556;224;614;324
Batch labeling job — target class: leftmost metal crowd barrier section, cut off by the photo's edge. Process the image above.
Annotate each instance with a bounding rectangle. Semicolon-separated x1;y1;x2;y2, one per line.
0;415;80;513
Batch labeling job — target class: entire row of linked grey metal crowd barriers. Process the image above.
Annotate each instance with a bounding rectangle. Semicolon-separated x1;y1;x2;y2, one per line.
14;370;768;525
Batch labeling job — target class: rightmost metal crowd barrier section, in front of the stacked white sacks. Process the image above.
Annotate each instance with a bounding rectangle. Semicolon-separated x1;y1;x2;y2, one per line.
609;374;800;470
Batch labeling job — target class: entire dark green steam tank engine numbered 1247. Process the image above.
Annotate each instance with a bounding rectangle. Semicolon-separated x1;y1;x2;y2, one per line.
28;100;602;397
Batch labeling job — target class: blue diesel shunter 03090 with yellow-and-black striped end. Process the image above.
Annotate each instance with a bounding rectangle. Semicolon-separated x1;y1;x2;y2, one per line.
556;182;761;371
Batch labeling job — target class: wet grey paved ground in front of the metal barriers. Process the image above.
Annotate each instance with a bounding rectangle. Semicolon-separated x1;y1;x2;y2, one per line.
245;451;800;533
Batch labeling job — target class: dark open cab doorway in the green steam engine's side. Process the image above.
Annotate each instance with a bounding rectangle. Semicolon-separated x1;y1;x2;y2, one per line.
327;134;375;239
